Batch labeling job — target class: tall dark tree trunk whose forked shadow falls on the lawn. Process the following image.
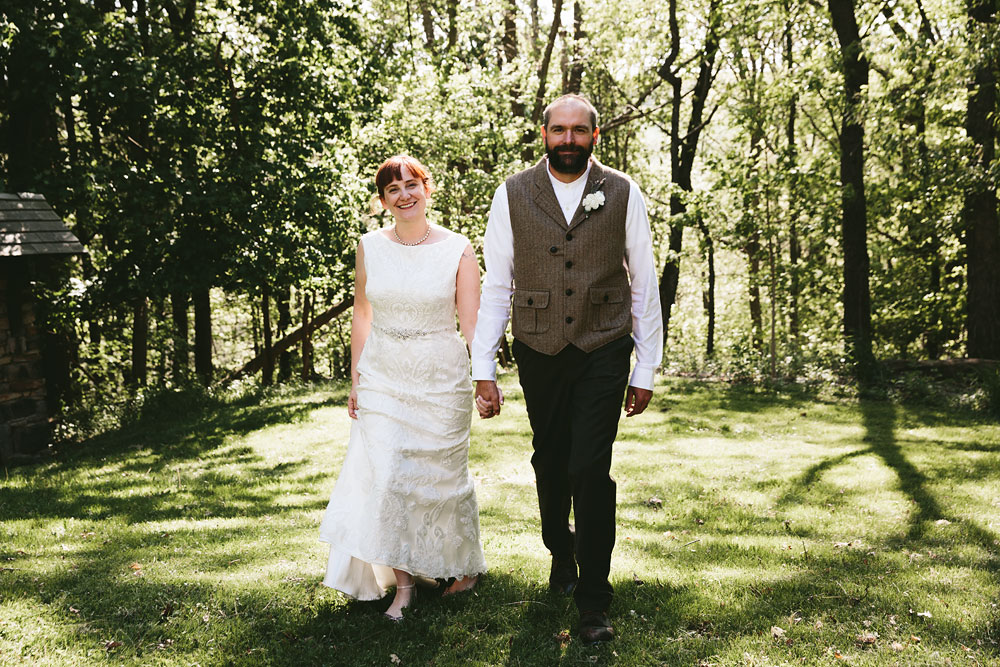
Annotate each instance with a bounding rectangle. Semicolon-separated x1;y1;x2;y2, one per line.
827;0;875;382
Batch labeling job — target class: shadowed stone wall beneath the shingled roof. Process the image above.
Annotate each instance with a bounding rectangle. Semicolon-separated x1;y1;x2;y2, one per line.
0;260;52;465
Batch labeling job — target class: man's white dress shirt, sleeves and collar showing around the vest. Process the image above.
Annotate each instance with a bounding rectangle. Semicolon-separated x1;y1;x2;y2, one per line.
471;160;663;390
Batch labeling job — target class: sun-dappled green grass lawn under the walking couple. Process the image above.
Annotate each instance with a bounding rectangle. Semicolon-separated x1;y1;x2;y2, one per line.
0;375;1000;665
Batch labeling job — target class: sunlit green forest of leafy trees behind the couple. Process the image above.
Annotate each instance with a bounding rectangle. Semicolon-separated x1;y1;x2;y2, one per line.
0;0;1000;437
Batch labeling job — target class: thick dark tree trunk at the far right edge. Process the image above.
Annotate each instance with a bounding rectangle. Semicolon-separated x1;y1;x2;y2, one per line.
962;0;1000;359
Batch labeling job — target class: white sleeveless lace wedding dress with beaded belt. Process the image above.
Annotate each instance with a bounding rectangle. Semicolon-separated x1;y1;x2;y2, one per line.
320;230;486;600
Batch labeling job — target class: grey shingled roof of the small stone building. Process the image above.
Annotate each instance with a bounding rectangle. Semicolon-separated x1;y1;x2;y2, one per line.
0;193;86;257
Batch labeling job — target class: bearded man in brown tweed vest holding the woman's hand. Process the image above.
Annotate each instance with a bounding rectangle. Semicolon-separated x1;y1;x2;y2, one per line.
472;95;663;643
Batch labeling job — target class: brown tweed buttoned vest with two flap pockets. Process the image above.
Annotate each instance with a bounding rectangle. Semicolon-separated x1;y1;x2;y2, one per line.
507;159;632;354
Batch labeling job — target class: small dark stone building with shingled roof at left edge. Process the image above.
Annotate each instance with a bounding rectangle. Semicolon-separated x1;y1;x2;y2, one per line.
0;194;85;466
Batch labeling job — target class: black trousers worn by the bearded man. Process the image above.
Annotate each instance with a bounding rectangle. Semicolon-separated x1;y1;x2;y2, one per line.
512;336;633;611
